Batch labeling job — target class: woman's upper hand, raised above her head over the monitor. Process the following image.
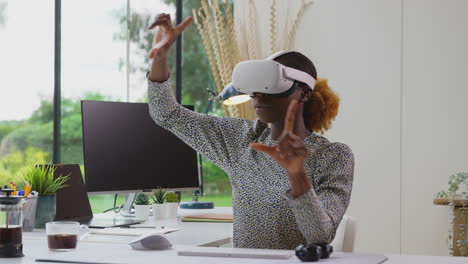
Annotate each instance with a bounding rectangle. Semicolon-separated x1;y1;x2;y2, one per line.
148;13;193;58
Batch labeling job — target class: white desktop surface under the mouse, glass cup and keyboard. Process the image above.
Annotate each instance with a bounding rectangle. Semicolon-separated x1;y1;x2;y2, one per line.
6;207;468;264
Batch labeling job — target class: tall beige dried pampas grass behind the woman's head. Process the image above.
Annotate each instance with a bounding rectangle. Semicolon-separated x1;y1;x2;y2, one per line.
192;0;314;119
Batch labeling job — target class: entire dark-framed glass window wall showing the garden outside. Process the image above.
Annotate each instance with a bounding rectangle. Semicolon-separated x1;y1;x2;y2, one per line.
0;0;231;210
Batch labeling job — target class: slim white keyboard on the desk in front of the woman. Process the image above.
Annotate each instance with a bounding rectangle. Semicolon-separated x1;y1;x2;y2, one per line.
177;247;295;259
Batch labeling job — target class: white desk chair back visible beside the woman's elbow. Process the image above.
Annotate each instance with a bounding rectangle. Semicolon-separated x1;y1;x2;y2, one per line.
331;215;357;252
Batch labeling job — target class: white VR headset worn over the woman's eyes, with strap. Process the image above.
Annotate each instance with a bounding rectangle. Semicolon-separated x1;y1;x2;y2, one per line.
228;51;315;96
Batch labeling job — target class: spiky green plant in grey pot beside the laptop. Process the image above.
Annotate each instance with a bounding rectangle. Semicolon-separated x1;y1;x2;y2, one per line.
19;165;69;228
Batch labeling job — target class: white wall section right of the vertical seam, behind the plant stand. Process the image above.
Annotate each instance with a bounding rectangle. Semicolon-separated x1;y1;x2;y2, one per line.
401;0;468;254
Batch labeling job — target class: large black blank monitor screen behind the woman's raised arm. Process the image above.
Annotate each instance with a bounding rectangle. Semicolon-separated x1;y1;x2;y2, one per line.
81;101;199;192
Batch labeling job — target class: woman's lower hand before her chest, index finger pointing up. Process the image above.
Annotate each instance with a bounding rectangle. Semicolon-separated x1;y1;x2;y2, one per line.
250;100;309;173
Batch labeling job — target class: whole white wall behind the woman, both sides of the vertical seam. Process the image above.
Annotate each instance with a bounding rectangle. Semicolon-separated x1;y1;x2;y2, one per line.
235;0;468;255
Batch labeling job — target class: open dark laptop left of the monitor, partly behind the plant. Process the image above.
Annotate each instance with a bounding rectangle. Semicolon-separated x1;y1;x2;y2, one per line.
49;164;143;228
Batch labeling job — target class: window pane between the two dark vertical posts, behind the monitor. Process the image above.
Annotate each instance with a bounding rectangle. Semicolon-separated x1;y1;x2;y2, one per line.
61;0;175;213
